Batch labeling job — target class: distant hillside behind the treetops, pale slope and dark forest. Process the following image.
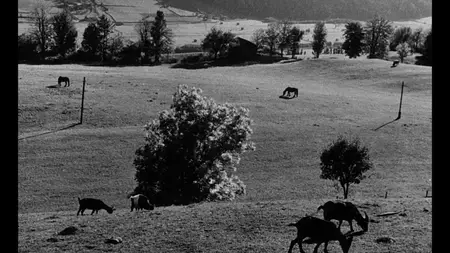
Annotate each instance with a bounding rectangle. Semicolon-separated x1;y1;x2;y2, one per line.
18;0;431;22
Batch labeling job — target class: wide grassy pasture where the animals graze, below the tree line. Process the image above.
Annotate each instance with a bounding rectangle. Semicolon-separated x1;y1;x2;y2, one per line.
18;56;432;252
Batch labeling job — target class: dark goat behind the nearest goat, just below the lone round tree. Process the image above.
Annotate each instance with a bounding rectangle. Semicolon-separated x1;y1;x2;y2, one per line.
317;201;369;232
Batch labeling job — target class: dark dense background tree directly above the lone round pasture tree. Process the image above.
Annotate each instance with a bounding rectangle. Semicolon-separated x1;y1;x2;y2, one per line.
342;22;364;58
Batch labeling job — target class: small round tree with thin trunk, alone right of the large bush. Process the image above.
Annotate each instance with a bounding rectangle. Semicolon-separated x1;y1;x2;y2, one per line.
320;136;373;199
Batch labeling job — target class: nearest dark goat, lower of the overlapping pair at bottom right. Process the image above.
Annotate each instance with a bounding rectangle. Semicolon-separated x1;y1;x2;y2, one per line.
288;216;361;253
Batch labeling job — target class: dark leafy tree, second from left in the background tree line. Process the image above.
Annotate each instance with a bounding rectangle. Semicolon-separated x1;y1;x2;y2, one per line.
52;10;78;57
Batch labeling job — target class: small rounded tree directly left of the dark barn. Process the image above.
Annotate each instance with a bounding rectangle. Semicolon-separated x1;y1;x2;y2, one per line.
202;27;235;59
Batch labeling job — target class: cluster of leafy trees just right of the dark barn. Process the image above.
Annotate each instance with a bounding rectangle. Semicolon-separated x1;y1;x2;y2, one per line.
251;20;305;58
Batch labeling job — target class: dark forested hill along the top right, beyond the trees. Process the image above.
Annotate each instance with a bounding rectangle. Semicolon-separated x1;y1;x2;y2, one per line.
158;0;432;21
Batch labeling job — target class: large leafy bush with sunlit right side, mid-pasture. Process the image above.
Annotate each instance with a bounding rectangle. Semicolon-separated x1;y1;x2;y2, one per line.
134;85;254;205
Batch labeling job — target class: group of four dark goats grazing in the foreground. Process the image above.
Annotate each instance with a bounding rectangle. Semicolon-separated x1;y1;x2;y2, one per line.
77;194;369;253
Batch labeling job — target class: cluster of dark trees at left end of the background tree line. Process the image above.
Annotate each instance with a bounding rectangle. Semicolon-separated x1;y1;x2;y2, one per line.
18;1;173;64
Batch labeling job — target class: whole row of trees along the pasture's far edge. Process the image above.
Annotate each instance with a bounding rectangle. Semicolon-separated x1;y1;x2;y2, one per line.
18;1;432;65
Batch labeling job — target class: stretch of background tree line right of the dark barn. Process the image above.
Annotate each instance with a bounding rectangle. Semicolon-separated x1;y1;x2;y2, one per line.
251;15;432;65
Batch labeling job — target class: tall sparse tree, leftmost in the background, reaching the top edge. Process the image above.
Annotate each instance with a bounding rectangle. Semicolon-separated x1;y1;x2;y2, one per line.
31;0;52;58
